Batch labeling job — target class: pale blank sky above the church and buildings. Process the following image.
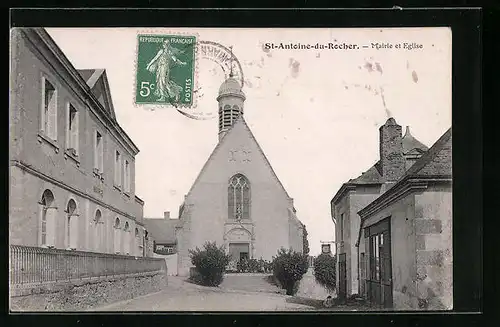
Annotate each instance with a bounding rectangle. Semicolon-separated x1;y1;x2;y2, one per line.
47;28;451;255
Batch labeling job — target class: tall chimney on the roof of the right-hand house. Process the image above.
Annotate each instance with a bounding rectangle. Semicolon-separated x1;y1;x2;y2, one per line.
379;117;405;182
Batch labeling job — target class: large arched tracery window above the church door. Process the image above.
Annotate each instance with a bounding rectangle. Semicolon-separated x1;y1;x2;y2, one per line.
228;174;250;220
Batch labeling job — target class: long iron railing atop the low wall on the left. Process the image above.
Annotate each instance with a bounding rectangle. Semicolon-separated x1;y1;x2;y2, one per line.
10;245;167;285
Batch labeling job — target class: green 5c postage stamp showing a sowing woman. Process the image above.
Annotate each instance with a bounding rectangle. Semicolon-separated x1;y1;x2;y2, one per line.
135;34;196;107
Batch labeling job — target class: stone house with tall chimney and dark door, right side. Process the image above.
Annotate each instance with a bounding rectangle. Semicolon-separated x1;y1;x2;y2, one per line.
331;118;452;309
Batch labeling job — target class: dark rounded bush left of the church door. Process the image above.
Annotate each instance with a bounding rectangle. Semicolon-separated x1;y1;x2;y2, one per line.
189;242;230;286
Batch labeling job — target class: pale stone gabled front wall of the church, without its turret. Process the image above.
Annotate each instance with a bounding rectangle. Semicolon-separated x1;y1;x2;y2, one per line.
174;120;302;276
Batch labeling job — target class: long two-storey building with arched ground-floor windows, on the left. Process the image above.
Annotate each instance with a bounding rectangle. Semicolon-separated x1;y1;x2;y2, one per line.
9;28;145;256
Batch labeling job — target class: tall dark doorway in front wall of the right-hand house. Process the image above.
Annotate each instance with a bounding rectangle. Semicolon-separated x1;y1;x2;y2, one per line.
365;217;393;308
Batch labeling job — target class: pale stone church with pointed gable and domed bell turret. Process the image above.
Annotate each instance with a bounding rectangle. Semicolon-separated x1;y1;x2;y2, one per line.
175;74;304;276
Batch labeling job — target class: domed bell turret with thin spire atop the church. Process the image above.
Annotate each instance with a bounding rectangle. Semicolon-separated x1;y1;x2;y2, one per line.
217;47;246;141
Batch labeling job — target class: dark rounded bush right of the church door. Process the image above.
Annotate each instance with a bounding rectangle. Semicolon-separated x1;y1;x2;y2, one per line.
272;248;309;295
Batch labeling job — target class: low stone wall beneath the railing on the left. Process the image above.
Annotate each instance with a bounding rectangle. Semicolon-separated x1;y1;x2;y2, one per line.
10;272;167;311
